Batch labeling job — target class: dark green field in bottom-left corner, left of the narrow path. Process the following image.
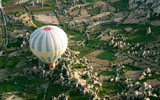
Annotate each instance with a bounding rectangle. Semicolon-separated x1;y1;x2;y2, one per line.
0;76;44;100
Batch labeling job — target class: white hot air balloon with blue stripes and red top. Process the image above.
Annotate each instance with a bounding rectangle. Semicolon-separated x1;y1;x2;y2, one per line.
29;25;68;70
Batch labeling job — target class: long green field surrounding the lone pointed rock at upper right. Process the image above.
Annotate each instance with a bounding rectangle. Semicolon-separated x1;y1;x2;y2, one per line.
99;24;160;43
